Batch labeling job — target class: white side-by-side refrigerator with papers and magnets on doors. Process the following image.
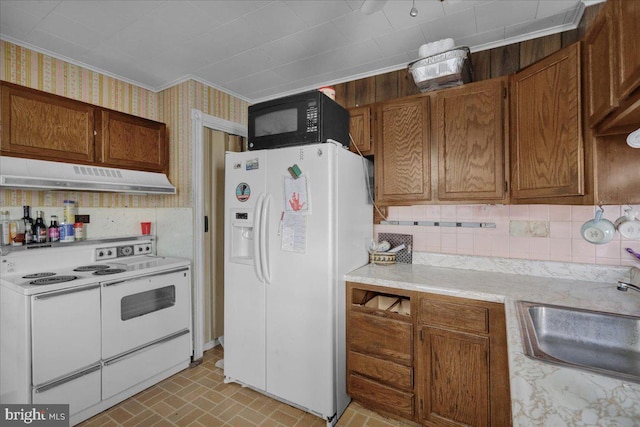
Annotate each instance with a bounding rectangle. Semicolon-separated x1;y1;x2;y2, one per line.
224;142;373;425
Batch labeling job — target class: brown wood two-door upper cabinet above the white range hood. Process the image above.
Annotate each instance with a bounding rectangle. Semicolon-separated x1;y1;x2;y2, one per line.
0;82;169;173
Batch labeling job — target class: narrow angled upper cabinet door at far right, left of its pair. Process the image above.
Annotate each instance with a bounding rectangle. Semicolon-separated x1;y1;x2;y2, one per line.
584;4;617;127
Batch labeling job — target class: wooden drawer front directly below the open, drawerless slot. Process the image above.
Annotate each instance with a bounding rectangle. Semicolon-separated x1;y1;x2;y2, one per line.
349;312;413;365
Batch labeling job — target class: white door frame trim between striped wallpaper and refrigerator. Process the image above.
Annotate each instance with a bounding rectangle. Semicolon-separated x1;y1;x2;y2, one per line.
191;108;248;360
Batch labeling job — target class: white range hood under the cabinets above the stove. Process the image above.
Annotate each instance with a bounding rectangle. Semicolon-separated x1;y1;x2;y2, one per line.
0;156;176;194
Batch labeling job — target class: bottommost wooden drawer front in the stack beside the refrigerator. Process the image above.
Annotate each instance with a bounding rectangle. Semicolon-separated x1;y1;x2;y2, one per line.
349;374;415;419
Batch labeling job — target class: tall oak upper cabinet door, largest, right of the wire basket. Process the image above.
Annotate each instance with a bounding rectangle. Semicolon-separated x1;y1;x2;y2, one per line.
511;43;585;203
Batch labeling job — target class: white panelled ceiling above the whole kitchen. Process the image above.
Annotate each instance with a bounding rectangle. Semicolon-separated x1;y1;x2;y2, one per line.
0;0;599;102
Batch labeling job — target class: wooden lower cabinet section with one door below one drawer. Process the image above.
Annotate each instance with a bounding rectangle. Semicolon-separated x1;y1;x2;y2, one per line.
416;293;511;427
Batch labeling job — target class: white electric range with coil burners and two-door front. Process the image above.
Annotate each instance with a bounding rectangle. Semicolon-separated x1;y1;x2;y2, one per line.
0;236;192;424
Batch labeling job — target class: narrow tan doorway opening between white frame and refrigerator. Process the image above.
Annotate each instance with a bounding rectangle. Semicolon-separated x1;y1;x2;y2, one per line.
202;128;245;343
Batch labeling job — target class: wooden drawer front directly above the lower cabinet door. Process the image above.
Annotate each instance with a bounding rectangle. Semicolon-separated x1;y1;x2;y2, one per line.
418;298;489;334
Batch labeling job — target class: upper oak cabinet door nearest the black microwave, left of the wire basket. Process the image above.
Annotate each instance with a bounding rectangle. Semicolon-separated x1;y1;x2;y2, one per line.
375;97;431;205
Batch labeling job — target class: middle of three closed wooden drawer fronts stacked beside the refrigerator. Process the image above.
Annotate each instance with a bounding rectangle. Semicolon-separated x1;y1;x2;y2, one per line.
348;351;413;391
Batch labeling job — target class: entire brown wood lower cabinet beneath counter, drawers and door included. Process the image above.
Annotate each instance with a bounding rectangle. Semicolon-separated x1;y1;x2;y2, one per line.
347;283;511;426
